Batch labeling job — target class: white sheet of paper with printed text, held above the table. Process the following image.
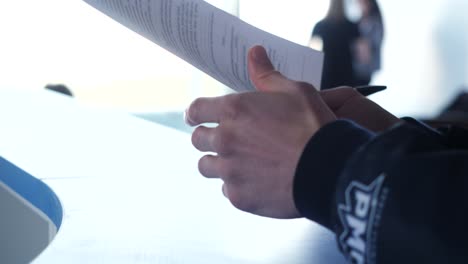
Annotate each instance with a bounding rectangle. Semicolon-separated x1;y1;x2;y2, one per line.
84;0;323;92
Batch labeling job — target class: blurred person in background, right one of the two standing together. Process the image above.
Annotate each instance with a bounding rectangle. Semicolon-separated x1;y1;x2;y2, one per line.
354;0;384;85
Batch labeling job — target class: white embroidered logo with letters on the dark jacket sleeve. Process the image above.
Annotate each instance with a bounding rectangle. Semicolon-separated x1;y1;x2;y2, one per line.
338;175;385;264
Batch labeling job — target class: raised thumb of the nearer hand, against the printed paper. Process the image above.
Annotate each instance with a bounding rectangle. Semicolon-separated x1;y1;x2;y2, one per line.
247;46;291;92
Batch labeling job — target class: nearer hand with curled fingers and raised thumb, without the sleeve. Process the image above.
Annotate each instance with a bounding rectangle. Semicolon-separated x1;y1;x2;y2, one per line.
186;47;336;218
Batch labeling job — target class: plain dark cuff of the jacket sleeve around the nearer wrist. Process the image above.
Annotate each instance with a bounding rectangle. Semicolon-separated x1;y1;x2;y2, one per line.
293;120;374;228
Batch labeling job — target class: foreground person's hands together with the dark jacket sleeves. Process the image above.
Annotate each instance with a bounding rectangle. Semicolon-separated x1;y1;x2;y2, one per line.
186;47;468;263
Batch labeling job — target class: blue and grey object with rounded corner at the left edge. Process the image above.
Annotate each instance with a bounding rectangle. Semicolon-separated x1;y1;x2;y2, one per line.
0;157;63;263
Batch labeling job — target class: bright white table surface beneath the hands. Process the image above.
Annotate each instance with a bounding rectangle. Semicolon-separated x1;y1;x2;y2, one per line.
0;90;344;264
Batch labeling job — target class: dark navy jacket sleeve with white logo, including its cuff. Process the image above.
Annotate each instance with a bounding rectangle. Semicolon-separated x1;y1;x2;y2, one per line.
294;120;468;263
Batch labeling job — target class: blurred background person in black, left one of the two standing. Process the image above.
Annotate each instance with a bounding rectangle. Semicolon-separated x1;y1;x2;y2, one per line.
309;0;359;89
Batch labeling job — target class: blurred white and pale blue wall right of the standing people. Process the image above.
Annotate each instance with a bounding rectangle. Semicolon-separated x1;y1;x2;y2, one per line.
374;0;468;116
